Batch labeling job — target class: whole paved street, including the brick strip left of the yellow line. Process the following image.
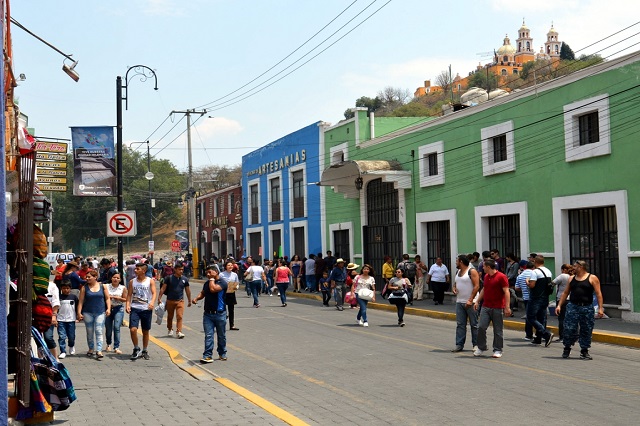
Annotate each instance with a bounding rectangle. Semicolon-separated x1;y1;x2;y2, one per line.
48;283;640;426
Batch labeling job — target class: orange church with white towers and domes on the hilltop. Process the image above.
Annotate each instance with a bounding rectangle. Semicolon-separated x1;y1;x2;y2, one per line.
413;19;562;98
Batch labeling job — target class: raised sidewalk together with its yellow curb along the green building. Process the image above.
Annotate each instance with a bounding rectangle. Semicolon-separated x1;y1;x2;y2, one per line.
287;292;640;348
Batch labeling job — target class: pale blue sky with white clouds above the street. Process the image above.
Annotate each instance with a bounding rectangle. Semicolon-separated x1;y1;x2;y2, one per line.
11;0;640;171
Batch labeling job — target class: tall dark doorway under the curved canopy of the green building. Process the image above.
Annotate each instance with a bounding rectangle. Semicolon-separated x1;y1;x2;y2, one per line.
362;178;403;290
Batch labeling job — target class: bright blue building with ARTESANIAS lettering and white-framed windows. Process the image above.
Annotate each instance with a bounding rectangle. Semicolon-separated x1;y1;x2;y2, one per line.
242;122;326;259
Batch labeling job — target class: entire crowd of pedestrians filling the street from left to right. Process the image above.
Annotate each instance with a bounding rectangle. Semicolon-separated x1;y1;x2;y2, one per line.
45;250;604;363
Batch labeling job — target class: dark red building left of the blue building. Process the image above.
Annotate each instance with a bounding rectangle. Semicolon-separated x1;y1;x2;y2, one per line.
196;185;244;261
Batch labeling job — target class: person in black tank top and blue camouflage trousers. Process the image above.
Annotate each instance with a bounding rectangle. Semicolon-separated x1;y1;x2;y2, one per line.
556;260;604;359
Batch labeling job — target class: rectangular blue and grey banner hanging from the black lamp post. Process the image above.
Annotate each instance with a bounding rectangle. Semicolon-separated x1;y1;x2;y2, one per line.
71;126;116;197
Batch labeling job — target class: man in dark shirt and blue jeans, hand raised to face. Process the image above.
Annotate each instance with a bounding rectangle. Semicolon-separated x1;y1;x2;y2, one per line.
192;266;227;364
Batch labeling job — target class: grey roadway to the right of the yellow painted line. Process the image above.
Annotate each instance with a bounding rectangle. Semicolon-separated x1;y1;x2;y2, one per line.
152;292;640;425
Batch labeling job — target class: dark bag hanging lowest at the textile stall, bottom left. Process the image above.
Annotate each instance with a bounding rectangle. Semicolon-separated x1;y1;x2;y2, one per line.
31;327;77;411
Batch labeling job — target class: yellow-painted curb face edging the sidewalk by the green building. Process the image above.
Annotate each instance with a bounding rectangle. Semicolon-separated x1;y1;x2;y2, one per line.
287;292;640;348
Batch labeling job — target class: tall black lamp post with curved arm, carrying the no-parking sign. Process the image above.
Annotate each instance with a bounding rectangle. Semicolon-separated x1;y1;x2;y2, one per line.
116;65;158;276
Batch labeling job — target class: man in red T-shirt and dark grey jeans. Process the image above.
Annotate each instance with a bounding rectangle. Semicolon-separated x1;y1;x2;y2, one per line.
473;259;511;358
